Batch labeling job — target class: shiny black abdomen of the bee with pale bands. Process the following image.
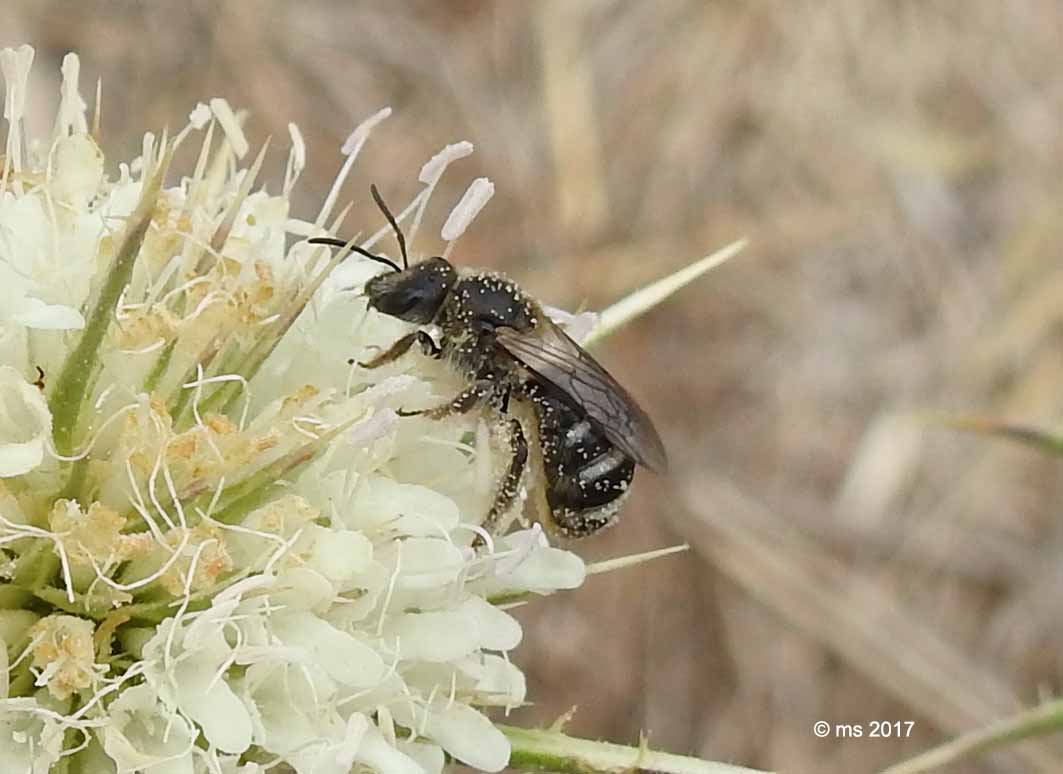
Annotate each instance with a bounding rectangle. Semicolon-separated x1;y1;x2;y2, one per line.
537;396;636;537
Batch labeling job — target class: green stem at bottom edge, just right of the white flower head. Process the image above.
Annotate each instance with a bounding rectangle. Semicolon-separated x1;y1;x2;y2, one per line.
497;725;764;774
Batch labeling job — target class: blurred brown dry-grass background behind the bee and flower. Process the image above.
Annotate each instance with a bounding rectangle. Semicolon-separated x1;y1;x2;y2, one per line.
10;0;1063;774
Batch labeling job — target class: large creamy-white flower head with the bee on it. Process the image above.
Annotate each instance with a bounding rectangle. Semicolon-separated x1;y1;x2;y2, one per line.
0;48;584;774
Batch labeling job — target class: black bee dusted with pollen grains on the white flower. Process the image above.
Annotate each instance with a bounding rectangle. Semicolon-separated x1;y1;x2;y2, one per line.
308;186;668;537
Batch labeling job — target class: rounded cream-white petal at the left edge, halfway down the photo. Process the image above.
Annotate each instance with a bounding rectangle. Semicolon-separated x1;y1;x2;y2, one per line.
0;366;52;477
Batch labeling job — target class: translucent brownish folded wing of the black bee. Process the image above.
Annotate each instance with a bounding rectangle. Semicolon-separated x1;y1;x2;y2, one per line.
495;320;668;473
